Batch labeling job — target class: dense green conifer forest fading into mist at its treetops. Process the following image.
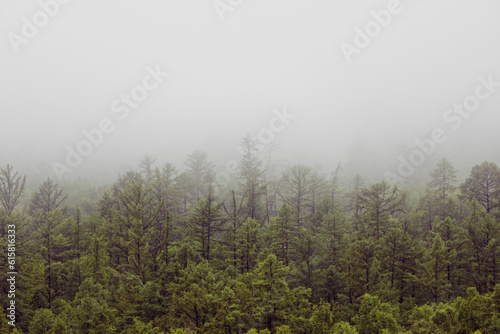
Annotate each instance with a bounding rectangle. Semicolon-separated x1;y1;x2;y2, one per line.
0;138;500;334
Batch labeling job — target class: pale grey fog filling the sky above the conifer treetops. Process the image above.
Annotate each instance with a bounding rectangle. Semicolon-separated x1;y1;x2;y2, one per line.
0;0;500;182
